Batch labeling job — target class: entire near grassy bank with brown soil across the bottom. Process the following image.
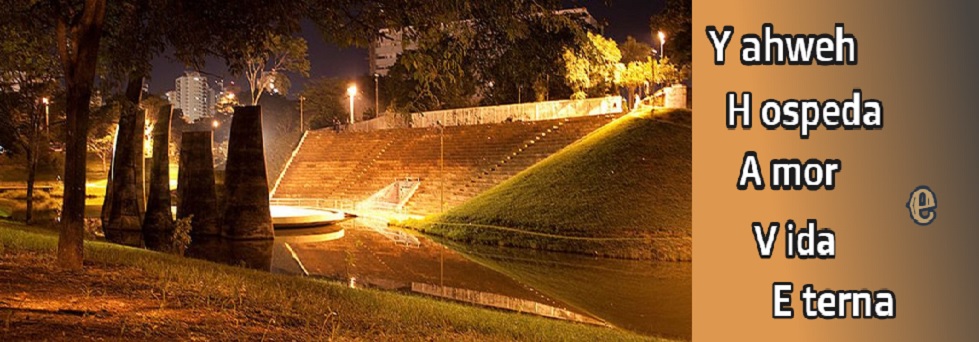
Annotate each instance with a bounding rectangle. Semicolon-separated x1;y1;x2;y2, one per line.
0;221;668;341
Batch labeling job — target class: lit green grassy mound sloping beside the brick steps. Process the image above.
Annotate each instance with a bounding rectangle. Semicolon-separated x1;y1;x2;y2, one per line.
412;108;692;260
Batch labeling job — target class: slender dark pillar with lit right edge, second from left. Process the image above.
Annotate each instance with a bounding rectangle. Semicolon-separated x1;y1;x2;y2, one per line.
143;105;174;251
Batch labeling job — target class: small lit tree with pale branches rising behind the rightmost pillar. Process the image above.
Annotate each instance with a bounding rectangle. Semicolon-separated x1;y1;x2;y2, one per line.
244;34;309;106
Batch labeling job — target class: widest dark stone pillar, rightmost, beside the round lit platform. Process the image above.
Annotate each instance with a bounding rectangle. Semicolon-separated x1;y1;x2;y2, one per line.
222;106;275;240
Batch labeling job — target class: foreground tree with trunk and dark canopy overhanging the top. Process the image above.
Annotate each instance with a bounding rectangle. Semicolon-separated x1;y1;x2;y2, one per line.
0;0;576;269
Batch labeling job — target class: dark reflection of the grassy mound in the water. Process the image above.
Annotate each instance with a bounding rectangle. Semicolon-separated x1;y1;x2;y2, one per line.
443;241;693;339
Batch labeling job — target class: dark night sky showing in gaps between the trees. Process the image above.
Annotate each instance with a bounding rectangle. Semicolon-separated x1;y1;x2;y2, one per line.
149;0;664;97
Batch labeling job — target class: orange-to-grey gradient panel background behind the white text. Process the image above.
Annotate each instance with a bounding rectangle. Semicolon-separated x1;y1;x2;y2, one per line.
692;0;979;341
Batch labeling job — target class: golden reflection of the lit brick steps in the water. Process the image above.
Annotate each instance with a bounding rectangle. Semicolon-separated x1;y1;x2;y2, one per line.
273;219;563;306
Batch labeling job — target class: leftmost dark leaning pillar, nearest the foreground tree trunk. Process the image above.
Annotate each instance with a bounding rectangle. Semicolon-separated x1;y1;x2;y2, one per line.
102;76;145;247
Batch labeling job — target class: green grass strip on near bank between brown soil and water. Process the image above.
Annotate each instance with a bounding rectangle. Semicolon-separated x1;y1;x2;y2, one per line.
0;221;668;341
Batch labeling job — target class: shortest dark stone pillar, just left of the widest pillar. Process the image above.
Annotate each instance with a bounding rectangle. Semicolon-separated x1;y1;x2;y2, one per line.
177;131;221;238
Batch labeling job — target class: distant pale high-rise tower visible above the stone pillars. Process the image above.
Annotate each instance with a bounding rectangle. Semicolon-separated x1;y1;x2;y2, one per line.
167;71;217;122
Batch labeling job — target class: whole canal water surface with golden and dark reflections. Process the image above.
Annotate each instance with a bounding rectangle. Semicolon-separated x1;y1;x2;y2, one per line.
249;219;692;339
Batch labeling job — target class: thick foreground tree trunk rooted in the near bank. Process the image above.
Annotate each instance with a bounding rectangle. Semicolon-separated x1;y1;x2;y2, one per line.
57;0;106;269
